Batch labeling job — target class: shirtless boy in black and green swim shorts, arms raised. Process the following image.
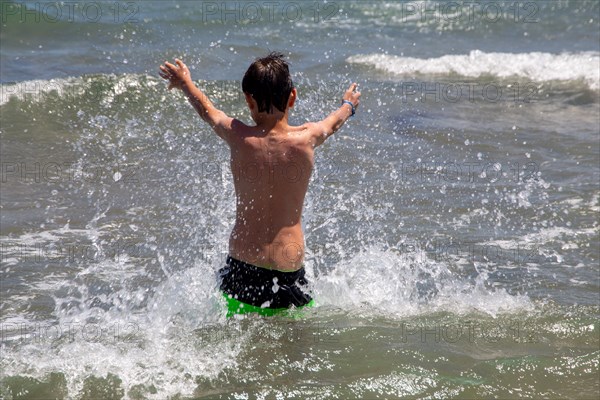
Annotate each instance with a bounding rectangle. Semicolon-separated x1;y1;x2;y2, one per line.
160;53;360;316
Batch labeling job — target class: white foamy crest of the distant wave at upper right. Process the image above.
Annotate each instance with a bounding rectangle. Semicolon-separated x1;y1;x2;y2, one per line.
346;50;600;90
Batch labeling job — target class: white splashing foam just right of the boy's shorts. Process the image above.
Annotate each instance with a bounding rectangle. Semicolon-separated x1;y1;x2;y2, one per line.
314;244;533;317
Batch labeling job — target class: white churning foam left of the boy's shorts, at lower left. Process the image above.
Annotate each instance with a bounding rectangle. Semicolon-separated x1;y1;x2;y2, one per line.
2;261;240;399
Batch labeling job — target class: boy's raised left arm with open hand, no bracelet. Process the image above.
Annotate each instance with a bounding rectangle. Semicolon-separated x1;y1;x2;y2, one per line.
159;59;234;143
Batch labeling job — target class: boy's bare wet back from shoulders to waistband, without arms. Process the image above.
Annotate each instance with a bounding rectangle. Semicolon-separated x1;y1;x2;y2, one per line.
229;121;314;270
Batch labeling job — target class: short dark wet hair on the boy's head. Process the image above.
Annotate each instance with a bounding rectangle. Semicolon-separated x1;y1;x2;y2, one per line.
242;52;294;114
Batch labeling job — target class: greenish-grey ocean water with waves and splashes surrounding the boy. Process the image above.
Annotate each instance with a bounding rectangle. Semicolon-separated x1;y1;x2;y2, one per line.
0;0;600;399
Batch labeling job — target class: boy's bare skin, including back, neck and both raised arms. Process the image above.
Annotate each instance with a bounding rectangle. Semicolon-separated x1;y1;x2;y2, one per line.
160;53;360;271
